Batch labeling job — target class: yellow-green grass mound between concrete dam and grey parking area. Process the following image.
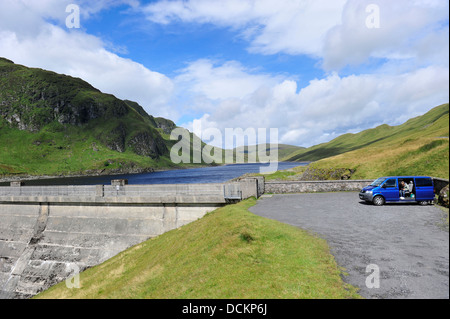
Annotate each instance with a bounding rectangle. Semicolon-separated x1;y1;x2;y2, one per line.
36;199;360;299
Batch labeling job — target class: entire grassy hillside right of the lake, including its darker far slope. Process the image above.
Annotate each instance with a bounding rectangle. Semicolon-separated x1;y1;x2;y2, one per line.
280;104;449;179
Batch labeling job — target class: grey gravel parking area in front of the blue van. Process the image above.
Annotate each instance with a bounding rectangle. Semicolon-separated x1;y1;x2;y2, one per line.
250;192;449;299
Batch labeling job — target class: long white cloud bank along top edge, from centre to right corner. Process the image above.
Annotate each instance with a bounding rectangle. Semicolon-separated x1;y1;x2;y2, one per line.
143;0;449;70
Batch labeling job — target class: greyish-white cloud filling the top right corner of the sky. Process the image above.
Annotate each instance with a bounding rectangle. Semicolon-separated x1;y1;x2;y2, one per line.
323;0;449;70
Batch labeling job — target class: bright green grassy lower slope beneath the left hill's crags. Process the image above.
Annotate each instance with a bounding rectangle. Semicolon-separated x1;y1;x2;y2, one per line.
0;119;171;175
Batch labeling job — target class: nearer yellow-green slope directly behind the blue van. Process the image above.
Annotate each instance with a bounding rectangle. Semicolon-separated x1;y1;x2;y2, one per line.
311;104;449;179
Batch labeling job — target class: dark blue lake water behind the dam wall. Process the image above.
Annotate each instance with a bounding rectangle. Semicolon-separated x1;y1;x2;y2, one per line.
0;162;306;186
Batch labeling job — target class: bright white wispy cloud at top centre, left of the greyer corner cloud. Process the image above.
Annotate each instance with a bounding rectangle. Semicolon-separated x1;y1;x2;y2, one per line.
143;0;345;55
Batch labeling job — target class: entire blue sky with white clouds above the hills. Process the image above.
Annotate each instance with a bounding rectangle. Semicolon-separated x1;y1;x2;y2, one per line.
0;0;449;146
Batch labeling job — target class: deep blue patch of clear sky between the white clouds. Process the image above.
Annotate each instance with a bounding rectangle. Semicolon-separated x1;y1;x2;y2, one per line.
83;1;324;80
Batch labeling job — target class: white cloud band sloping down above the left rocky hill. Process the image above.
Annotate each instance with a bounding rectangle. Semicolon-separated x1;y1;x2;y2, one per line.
0;0;174;118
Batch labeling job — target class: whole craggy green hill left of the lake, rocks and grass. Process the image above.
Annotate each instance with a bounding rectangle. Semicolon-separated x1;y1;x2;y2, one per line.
0;58;206;176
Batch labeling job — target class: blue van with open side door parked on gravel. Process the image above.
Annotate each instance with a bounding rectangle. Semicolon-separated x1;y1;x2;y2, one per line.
359;176;434;206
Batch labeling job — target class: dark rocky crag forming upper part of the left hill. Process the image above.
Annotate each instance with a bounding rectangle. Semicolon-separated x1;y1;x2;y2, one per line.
0;59;129;131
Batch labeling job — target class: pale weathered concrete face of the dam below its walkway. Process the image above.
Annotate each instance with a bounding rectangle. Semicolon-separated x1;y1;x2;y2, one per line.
0;203;223;299
